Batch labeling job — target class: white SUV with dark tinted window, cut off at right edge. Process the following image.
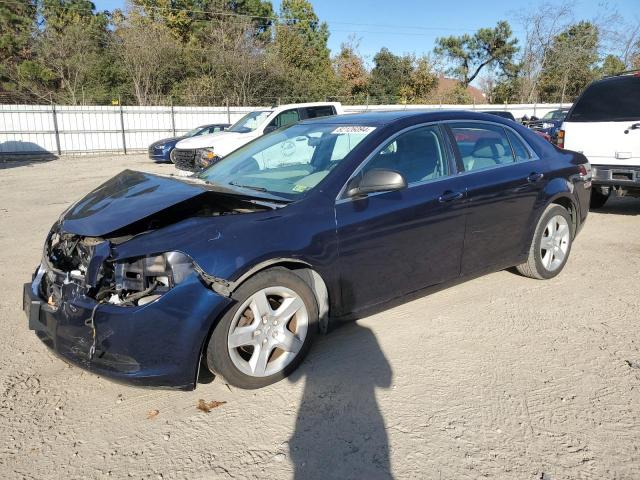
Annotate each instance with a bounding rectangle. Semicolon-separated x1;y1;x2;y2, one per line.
558;71;640;208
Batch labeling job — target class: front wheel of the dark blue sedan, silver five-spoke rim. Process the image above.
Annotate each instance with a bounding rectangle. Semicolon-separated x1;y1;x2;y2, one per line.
207;268;318;389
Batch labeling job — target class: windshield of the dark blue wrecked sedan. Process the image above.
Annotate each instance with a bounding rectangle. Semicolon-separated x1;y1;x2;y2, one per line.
198;124;375;200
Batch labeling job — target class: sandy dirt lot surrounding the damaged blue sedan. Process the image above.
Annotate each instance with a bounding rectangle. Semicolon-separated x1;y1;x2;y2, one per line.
0;156;640;480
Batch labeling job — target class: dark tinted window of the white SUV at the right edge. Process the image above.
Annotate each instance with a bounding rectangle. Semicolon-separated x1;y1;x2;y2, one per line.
566;75;640;122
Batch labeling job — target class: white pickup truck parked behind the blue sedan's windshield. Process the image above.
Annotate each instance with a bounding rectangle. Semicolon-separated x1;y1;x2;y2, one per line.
171;102;343;175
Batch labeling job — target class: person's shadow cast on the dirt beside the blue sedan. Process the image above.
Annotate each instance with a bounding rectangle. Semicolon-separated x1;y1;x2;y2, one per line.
289;322;393;480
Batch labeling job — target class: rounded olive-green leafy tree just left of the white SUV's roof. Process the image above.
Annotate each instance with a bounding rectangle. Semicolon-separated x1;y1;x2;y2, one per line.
540;22;598;102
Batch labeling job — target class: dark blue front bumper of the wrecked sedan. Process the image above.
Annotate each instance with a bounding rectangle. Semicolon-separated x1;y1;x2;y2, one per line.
23;266;231;389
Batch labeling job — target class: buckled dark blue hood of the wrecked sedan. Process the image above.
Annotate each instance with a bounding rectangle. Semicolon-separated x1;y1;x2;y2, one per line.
59;170;266;237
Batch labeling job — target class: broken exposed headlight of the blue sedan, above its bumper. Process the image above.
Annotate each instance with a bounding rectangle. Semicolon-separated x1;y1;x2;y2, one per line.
109;252;193;305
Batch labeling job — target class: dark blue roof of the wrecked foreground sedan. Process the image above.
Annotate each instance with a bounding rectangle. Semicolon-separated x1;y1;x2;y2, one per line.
300;109;516;126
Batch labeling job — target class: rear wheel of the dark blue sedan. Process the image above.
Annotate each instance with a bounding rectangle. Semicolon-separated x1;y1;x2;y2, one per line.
516;204;573;280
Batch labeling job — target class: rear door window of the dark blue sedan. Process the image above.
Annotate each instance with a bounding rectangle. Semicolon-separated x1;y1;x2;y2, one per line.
449;122;524;171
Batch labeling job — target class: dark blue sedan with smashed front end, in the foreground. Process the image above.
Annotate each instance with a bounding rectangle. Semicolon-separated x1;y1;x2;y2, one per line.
24;111;590;389
